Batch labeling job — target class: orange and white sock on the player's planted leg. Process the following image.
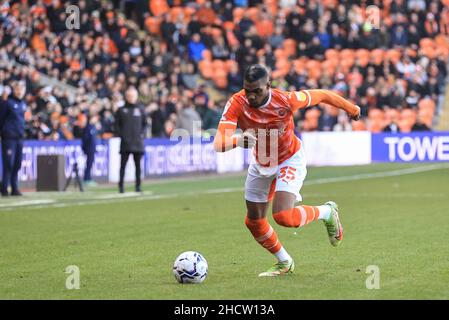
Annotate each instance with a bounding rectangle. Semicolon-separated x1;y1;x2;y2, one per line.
245;216;292;261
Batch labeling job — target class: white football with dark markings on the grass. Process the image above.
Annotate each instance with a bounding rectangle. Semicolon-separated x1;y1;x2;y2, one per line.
173;251;208;283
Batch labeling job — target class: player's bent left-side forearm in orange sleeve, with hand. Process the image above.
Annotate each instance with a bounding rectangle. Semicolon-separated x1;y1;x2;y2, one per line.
214;122;257;152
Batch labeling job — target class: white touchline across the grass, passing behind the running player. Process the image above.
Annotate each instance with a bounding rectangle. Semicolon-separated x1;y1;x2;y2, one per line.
0;163;449;211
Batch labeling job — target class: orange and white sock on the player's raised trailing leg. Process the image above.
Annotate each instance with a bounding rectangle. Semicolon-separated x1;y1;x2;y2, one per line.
273;205;331;228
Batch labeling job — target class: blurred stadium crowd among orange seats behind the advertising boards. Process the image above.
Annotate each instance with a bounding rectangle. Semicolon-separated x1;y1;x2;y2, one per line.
0;0;449;140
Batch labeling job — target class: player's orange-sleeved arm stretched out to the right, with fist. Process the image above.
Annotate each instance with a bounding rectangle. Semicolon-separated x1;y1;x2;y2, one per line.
290;89;360;120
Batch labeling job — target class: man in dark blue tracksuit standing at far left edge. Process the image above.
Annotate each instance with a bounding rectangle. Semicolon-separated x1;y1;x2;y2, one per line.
0;81;27;196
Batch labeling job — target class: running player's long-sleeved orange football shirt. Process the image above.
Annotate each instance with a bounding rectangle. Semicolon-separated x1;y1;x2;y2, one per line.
215;89;358;166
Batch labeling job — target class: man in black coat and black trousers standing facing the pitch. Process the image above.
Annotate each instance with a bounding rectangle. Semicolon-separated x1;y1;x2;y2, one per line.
115;86;147;193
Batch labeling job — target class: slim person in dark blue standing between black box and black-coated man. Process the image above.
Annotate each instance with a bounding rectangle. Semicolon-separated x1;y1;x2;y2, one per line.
80;115;97;186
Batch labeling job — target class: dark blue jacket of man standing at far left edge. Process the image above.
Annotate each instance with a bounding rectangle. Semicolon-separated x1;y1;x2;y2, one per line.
0;95;26;139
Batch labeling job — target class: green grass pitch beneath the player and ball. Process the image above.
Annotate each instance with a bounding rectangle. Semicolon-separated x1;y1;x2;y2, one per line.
0;164;449;300
